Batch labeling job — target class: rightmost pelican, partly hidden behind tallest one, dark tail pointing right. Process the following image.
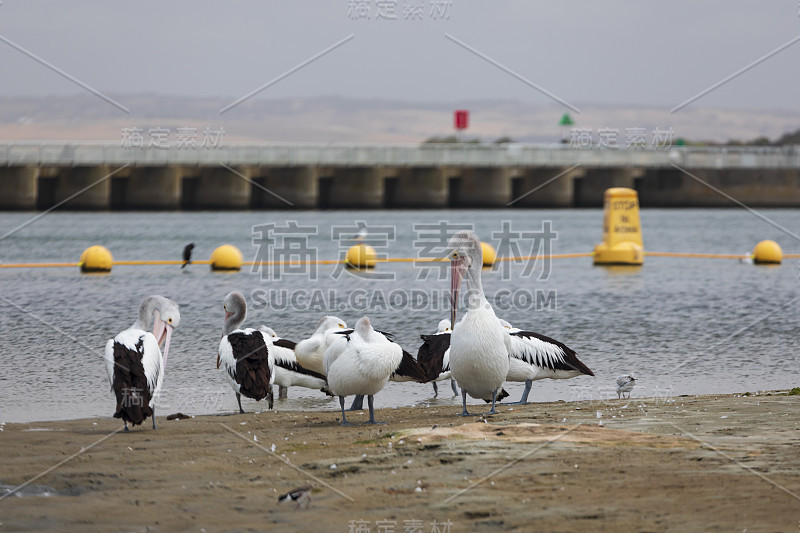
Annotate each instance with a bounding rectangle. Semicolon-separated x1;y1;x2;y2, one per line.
500;320;594;405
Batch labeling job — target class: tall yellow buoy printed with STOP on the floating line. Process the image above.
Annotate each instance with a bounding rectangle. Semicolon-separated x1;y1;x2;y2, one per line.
594;187;644;265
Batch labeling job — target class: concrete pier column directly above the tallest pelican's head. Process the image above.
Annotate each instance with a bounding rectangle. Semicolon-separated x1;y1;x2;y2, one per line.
451;167;512;207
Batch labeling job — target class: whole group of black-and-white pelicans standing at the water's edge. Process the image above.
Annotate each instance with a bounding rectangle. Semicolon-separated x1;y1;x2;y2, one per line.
106;231;608;430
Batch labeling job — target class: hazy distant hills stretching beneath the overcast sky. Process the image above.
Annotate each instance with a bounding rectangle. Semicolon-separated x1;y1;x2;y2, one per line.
0;94;800;144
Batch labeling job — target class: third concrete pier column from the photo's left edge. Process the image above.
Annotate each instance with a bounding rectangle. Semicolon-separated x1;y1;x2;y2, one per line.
122;166;182;209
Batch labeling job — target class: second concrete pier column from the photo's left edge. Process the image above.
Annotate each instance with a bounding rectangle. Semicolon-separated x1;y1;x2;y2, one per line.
55;166;112;209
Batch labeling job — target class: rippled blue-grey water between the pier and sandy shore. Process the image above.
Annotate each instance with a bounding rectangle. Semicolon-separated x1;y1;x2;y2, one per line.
0;210;800;422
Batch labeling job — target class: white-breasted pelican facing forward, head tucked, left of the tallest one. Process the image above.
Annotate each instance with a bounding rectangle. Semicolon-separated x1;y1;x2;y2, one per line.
324;317;403;426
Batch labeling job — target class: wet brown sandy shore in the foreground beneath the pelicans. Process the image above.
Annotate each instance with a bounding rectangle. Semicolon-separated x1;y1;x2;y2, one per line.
0;392;800;533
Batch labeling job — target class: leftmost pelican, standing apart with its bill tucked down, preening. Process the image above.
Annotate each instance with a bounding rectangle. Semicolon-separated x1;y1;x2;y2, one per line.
105;296;181;431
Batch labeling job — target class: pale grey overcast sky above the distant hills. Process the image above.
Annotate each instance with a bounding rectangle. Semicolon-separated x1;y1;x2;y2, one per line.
0;0;800;112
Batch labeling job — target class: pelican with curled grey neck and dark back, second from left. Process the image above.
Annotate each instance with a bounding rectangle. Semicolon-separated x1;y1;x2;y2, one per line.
217;291;275;413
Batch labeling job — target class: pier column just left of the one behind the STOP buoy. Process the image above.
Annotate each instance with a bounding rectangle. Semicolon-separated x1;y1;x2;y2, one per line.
511;167;585;208
